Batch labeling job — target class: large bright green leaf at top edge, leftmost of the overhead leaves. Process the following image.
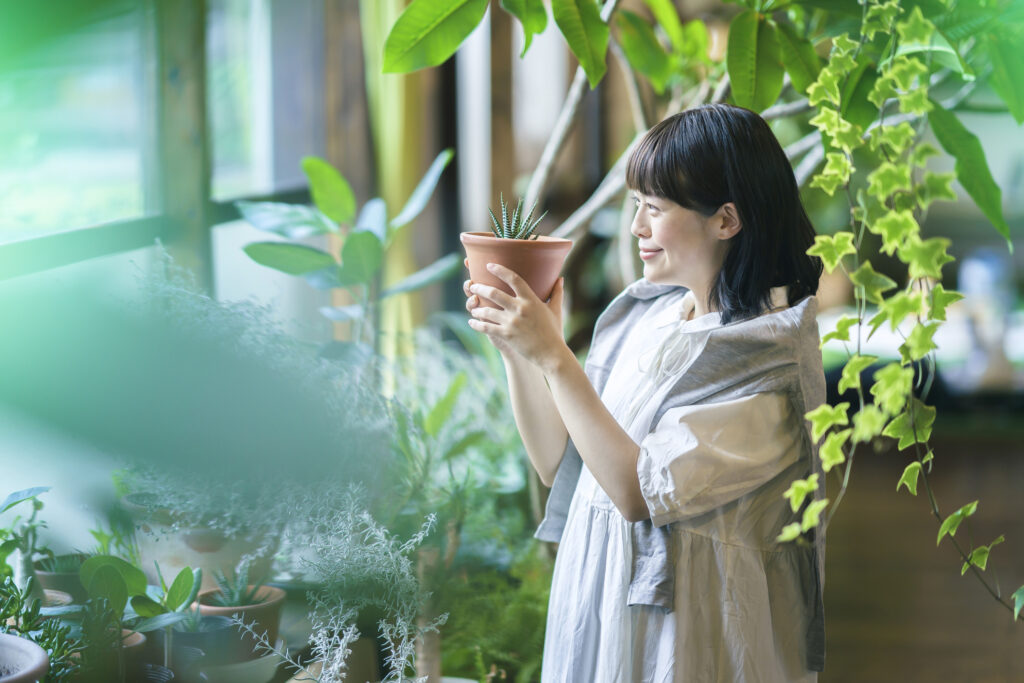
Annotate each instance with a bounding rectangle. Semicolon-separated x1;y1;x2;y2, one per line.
383;0;487;74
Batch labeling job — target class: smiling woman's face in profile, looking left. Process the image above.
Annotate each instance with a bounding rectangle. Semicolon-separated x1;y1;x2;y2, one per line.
630;191;738;295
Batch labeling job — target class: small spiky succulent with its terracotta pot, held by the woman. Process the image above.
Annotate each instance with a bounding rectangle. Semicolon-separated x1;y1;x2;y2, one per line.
460;197;572;307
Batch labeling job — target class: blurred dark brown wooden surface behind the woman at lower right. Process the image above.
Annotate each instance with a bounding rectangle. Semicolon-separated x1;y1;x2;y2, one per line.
819;437;1024;683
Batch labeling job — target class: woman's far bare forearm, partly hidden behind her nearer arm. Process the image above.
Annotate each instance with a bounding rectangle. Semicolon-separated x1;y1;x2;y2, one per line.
502;351;568;486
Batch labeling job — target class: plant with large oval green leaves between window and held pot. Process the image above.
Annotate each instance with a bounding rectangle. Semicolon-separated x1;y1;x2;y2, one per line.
237;150;461;360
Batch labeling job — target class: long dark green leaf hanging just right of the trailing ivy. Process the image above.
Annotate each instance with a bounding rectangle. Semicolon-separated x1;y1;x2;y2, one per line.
928;101;1013;251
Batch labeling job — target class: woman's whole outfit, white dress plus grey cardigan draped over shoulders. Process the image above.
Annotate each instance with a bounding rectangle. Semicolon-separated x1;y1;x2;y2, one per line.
537;280;824;683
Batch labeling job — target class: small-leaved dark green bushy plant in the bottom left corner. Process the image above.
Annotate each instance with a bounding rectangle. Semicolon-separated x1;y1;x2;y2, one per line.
0;577;85;683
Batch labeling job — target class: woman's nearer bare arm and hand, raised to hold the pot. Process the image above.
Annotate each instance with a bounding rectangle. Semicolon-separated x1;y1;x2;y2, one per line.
469;264;650;521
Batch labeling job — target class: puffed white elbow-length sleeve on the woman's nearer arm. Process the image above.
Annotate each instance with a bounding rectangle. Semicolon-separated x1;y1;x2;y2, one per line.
637;392;804;526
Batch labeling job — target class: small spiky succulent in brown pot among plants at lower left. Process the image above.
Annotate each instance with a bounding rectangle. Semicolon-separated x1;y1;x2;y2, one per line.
198;564;286;658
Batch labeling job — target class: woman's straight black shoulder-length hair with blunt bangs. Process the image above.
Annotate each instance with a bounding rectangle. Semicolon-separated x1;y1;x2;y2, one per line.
626;104;821;323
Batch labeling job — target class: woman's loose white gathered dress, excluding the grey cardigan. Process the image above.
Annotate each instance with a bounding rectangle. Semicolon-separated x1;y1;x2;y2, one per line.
542;294;817;683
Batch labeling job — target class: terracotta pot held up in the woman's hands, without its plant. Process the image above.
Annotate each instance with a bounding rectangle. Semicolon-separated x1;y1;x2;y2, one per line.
459;232;572;308
